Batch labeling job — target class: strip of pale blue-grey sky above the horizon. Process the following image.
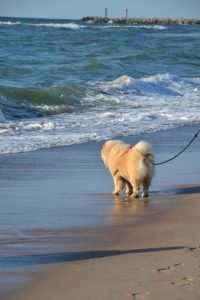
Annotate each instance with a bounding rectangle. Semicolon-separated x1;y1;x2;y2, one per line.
0;0;200;19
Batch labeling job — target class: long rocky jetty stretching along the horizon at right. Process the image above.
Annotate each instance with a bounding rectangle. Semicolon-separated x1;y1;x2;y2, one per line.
80;17;200;25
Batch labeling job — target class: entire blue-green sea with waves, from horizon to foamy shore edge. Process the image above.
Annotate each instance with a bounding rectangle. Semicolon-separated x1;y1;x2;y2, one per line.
0;18;200;153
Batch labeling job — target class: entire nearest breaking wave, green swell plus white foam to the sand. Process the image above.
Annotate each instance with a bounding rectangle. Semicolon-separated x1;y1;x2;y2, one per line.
0;73;200;153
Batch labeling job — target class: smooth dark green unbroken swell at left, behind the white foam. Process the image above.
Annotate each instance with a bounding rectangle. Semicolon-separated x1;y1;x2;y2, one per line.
0;84;85;122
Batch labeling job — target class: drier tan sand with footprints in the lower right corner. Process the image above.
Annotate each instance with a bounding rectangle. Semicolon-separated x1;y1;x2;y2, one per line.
4;194;200;300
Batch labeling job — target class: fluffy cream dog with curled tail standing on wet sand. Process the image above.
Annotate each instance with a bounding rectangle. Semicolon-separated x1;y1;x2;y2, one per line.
101;140;154;197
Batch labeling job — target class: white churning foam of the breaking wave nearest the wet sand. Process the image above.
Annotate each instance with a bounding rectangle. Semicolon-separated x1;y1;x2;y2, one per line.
0;74;200;153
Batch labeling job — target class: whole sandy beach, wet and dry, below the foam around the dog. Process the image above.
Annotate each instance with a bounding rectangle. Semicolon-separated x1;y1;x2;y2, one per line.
0;125;200;300
